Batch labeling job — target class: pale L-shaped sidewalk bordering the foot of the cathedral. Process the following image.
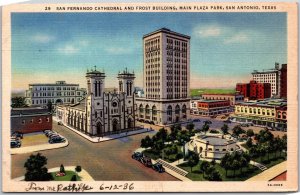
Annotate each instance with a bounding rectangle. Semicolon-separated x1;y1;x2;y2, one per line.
64;125;151;143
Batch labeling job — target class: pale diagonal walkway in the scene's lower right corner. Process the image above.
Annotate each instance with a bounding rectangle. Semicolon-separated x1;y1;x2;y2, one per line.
246;161;287;181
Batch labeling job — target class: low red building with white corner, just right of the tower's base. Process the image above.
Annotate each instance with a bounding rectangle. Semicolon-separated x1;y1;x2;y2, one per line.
190;99;233;116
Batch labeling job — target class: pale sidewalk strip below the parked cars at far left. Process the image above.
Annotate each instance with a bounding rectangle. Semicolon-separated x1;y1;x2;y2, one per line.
10;139;69;155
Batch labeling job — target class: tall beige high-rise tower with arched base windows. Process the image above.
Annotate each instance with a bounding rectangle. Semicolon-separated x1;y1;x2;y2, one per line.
137;28;190;125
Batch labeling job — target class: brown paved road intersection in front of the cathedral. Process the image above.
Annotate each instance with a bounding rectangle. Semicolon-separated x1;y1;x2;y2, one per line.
12;123;177;181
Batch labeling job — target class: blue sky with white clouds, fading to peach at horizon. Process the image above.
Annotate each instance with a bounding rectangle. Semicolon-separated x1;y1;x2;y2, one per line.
11;12;287;90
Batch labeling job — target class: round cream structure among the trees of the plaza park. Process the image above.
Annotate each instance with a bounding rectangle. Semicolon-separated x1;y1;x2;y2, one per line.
188;135;240;159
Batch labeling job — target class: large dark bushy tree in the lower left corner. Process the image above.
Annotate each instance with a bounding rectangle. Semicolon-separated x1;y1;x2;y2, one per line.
24;153;53;181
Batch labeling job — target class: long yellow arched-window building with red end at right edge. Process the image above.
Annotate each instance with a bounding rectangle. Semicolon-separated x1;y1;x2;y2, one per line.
232;99;287;129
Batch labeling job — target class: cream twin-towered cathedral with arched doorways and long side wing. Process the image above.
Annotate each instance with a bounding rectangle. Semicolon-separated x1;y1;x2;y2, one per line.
56;68;135;137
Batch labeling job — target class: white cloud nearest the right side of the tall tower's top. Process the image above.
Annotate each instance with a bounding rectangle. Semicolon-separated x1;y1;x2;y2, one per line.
195;24;224;38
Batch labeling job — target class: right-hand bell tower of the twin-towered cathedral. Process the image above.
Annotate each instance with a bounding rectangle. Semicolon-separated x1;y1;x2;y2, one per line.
118;68;135;96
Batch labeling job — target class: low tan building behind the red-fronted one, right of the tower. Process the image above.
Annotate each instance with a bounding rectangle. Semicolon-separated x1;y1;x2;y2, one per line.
202;93;244;106
